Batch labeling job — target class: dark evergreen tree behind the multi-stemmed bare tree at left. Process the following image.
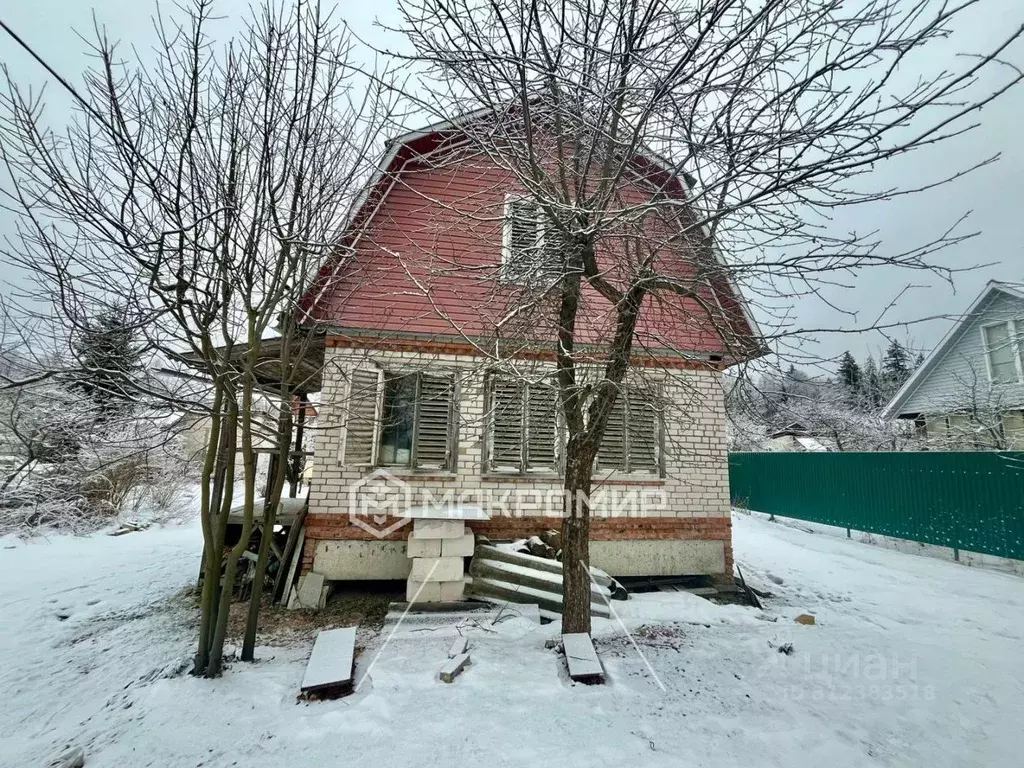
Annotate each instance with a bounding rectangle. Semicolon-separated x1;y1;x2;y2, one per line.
71;310;141;419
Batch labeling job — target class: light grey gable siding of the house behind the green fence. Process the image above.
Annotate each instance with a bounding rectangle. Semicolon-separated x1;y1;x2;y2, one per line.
898;290;1024;415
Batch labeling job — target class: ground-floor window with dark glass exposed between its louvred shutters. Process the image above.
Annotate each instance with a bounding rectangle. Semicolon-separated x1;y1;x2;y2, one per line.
343;370;456;470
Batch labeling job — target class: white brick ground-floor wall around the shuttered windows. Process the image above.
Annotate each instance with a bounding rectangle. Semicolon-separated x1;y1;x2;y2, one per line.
309;347;729;517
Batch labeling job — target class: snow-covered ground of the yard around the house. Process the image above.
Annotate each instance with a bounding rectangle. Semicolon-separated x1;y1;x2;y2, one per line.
0;514;1024;768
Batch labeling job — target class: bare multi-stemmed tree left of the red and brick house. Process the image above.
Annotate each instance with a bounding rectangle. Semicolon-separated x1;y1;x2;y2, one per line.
0;0;387;677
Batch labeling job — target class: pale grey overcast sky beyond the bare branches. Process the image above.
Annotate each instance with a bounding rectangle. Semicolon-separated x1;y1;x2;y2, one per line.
0;0;1024;372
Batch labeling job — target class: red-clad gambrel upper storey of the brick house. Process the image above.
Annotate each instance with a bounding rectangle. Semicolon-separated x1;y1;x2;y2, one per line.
302;114;764;362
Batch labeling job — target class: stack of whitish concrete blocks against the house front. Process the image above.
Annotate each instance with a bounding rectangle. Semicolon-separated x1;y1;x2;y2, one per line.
406;519;474;603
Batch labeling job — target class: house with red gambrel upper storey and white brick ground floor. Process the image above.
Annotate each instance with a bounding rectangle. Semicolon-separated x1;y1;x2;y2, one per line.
294;114;761;580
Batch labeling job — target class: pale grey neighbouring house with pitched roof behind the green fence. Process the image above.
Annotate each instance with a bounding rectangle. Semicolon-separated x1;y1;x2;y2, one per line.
883;281;1024;451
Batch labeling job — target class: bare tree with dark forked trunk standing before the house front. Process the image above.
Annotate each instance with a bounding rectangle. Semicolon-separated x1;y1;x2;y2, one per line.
385;0;1021;632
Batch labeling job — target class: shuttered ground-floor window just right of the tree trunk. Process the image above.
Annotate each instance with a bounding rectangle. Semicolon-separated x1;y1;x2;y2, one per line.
597;388;662;474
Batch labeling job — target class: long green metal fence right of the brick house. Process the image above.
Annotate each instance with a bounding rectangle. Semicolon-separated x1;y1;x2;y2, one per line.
729;452;1024;559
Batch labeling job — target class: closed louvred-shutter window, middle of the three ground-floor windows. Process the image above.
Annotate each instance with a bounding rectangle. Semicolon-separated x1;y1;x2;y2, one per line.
487;375;561;473
